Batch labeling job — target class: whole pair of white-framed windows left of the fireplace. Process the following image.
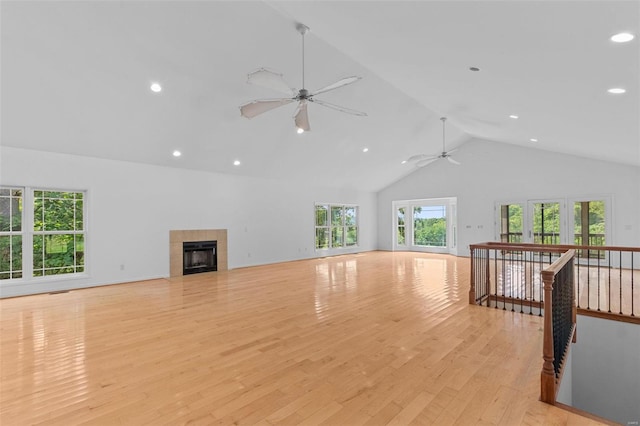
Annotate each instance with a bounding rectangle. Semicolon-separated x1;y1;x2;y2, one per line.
0;187;86;280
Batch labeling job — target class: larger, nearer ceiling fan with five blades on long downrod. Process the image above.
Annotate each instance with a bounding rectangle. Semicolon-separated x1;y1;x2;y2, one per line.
240;24;367;133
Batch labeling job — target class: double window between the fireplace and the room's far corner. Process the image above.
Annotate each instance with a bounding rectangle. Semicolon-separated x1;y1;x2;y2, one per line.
315;204;358;250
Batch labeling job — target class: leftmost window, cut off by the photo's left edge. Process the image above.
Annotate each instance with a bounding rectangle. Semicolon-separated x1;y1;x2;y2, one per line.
0;187;23;280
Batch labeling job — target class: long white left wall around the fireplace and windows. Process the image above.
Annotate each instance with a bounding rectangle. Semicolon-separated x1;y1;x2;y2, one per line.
0;147;377;297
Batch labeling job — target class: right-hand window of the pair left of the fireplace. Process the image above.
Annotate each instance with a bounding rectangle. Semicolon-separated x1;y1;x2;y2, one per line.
33;190;84;277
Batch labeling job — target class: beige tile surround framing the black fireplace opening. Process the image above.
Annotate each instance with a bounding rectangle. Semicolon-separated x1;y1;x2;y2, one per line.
169;229;228;277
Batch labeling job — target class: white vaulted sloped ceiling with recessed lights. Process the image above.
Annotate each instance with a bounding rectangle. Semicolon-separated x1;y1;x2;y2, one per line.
0;0;640;191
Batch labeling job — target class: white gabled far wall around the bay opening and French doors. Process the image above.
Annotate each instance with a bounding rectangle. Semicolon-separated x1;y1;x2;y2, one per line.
378;139;640;256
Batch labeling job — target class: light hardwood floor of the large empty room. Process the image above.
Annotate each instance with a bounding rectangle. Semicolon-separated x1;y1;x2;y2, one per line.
0;252;598;426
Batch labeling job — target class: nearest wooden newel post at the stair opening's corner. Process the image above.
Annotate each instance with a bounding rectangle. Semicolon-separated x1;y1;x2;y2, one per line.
540;271;556;404
